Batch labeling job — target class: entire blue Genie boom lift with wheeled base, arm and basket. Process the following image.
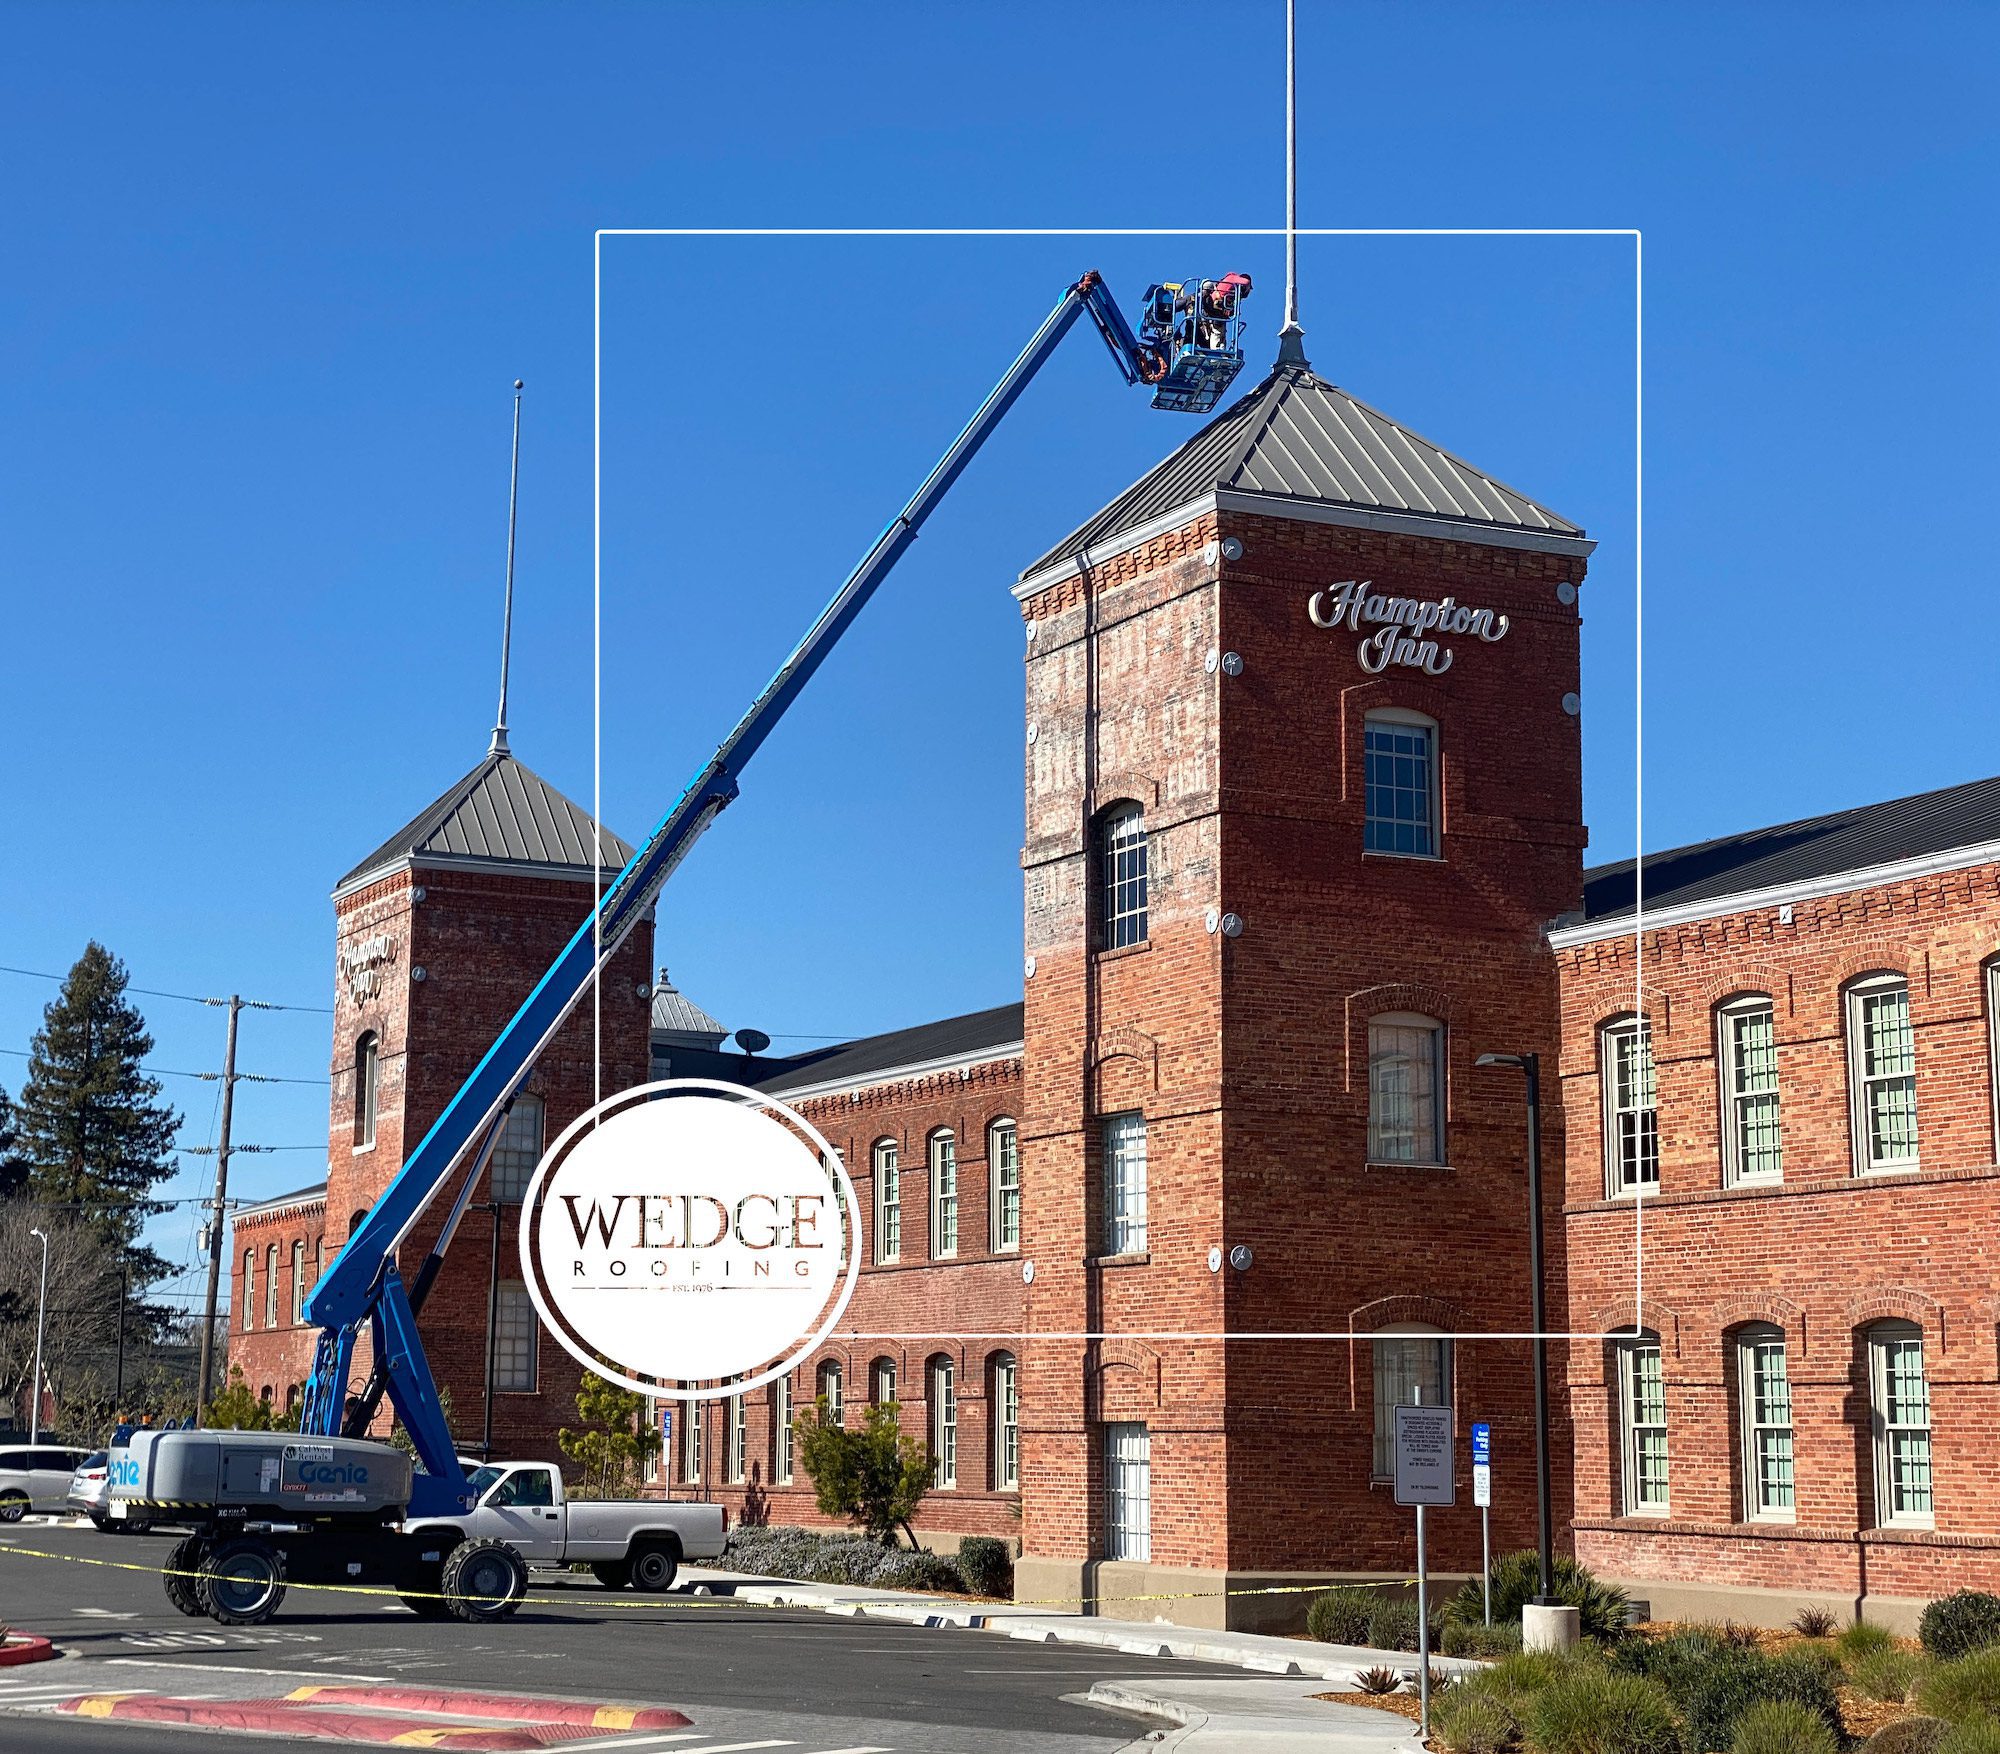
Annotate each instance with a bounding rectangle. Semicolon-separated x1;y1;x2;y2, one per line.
112;272;1250;1624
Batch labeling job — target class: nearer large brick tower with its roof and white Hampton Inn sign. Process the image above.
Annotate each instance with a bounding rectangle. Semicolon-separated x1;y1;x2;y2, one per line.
1016;342;1592;1626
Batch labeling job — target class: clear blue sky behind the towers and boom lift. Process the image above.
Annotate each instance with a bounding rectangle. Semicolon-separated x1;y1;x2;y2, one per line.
0;0;2000;1304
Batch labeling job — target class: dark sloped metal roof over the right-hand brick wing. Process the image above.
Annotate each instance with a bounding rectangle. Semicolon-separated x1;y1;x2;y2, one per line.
1582;776;2000;924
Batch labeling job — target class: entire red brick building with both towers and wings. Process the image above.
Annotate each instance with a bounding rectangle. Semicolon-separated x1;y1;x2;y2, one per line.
234;344;2000;1626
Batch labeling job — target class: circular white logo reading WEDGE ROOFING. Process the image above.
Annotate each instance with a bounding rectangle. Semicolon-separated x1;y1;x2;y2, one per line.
520;1078;860;1400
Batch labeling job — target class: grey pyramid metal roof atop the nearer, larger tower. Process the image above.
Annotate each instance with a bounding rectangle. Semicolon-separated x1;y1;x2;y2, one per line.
1022;364;1584;578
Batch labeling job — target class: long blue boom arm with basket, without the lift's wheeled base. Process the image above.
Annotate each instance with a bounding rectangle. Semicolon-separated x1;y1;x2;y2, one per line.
300;272;1250;1514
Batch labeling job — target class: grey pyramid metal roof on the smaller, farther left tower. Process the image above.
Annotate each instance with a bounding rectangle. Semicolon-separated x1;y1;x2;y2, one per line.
334;750;632;894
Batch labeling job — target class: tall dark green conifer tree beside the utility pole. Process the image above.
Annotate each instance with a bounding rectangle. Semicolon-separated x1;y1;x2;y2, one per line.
14;940;180;1296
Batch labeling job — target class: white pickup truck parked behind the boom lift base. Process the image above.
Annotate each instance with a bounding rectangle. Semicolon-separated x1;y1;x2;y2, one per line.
410;1462;726;1590
